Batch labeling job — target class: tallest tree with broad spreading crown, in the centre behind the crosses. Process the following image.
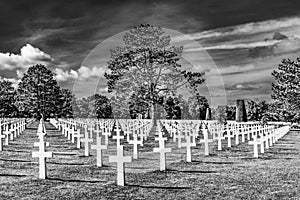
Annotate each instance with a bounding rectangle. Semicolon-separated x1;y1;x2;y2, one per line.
105;25;204;119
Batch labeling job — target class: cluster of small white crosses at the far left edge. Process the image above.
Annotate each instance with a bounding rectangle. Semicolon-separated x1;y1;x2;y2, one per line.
0;119;26;151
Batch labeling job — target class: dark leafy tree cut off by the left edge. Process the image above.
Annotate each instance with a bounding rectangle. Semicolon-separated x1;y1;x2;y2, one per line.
0;80;18;117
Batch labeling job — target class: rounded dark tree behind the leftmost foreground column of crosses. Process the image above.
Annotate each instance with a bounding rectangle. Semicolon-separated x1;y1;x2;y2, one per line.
17;65;61;118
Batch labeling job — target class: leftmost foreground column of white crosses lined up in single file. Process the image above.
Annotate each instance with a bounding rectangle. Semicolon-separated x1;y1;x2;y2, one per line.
32;119;53;179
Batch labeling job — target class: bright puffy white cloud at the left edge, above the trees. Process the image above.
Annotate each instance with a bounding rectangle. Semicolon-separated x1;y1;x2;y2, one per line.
0;44;53;70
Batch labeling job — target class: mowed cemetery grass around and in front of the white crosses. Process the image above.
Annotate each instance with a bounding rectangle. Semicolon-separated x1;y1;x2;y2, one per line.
0;122;300;200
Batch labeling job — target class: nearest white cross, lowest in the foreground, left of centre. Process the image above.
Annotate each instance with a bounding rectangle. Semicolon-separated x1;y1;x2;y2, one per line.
108;146;132;186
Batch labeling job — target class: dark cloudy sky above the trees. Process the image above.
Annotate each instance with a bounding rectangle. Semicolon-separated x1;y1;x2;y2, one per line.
0;0;300;105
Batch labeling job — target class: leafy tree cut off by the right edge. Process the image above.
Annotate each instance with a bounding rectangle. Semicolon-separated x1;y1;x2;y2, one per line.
271;58;300;122
